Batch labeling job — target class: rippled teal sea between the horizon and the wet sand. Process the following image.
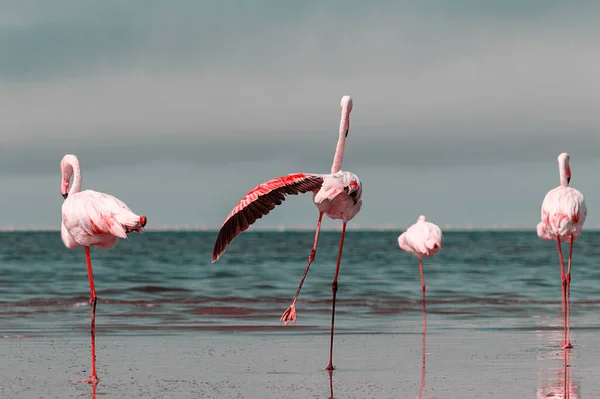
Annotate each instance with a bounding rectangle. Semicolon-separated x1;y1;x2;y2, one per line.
0;231;600;336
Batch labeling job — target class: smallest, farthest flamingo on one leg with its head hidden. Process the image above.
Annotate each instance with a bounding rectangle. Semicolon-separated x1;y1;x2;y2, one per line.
398;215;444;330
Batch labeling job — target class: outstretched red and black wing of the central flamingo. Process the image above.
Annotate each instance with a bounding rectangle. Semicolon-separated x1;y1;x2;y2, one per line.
212;173;323;263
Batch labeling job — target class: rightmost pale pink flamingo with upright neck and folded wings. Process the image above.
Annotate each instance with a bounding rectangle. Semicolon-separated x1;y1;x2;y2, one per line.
537;152;587;349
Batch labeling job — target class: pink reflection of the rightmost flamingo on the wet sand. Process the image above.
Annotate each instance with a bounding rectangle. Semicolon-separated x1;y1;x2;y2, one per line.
537;349;579;399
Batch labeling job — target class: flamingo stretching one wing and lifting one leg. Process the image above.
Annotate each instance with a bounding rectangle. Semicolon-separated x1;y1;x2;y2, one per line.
212;96;362;370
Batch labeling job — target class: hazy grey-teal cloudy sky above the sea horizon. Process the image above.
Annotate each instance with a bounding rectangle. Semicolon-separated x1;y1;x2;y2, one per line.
0;0;600;229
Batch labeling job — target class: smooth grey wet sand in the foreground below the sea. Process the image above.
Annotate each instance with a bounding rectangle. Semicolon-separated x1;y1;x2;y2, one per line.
0;323;600;399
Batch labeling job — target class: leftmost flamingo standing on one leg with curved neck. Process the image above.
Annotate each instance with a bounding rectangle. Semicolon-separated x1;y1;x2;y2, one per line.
60;154;146;385
